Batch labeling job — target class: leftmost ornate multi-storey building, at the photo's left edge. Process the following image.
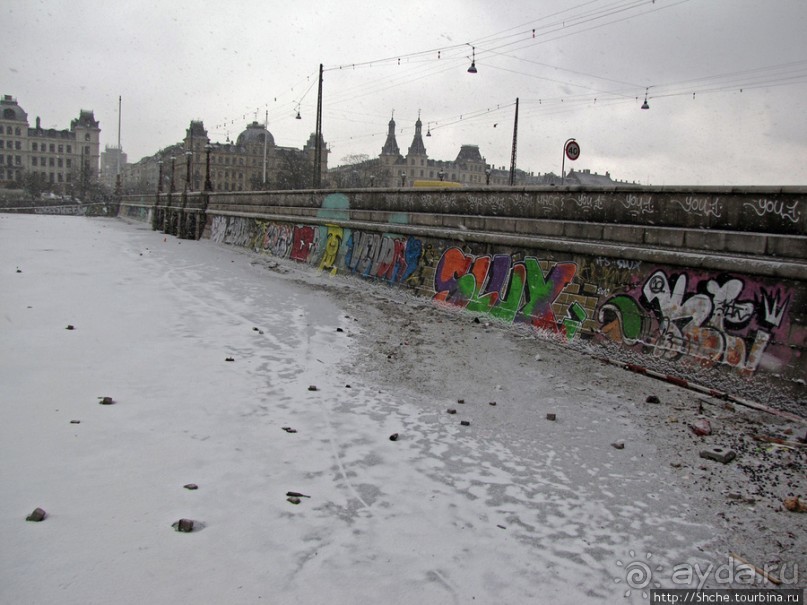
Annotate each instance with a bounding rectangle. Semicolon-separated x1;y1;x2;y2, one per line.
0;95;101;194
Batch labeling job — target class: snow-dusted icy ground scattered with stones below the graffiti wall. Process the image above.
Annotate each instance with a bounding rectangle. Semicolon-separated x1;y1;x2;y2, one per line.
0;215;807;605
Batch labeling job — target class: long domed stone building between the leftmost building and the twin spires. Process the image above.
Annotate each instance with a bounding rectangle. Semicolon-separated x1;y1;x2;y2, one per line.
123;120;328;193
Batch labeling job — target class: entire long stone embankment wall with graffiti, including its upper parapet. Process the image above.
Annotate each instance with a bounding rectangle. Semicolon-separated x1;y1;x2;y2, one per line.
120;187;807;399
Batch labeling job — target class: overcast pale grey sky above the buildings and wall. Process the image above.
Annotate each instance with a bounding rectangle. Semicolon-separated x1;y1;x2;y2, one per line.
6;0;807;185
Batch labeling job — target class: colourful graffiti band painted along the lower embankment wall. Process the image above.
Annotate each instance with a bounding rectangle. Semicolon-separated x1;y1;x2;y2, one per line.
200;189;807;386
